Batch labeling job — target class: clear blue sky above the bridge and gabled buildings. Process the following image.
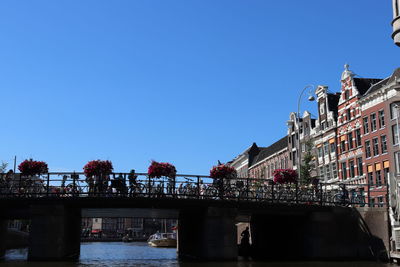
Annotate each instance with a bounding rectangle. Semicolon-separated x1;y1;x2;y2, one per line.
0;0;400;174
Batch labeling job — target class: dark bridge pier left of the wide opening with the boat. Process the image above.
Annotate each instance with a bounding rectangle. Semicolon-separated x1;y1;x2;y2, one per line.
28;205;81;261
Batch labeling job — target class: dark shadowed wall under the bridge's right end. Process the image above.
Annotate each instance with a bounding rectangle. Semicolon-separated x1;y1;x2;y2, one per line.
251;207;389;261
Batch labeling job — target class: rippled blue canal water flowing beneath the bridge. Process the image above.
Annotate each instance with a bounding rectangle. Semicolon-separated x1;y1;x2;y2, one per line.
0;242;394;267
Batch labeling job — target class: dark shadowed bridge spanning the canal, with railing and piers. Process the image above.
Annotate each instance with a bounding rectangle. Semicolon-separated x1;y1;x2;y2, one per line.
0;173;389;260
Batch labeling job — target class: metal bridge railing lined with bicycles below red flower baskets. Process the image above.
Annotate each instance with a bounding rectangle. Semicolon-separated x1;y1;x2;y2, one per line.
0;172;387;206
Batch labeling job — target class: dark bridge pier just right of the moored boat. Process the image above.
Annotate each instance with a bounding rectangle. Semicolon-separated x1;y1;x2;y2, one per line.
178;208;238;260
